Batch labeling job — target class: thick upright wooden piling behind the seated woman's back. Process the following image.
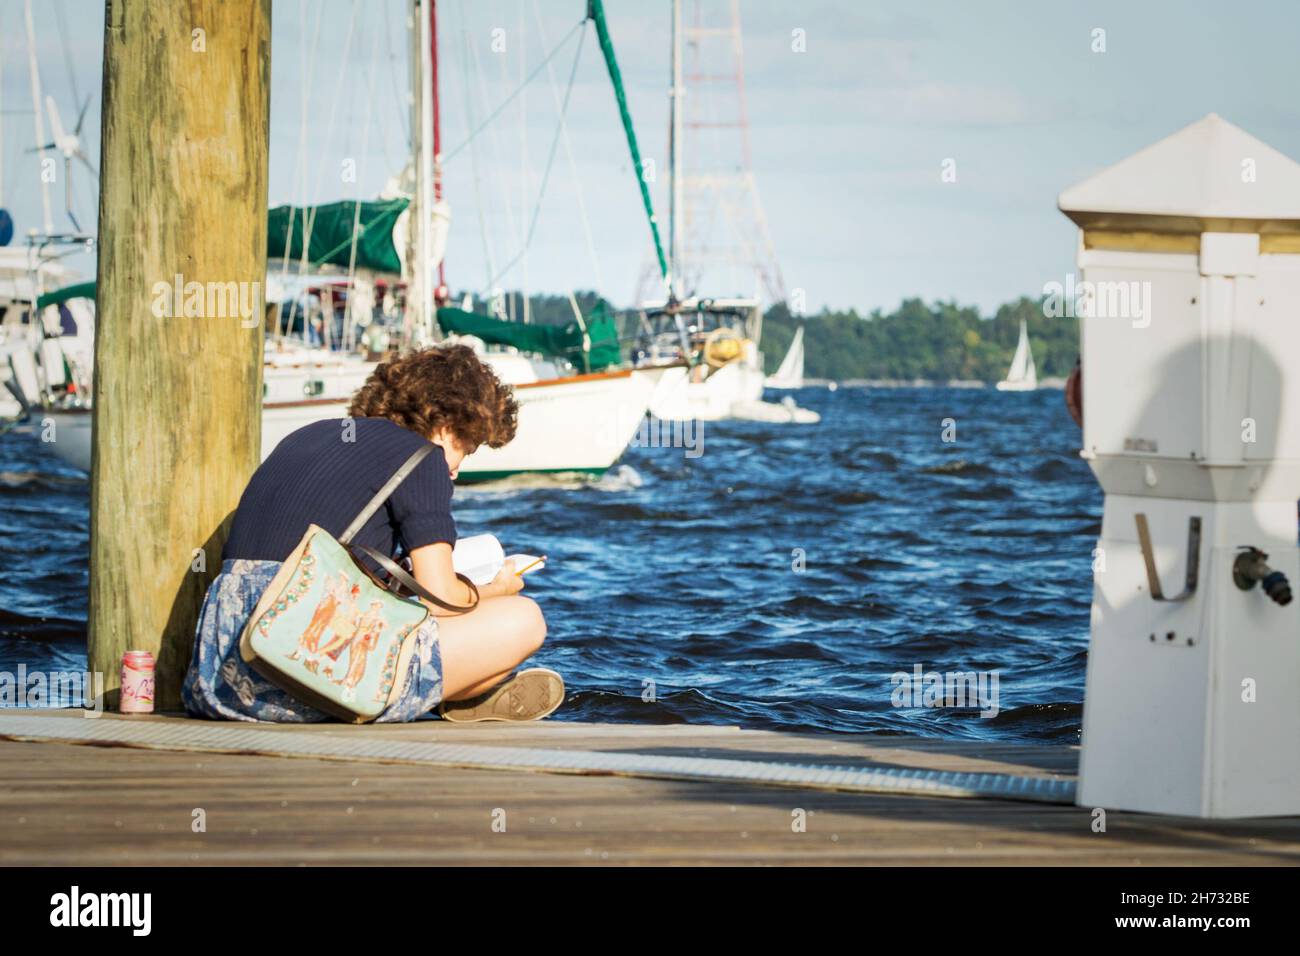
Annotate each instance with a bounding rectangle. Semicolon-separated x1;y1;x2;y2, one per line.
88;0;270;708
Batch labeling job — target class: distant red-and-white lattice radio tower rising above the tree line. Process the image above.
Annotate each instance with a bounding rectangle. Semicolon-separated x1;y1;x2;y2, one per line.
634;0;785;306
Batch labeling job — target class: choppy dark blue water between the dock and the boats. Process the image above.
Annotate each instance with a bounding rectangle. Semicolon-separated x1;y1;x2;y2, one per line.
0;388;1101;743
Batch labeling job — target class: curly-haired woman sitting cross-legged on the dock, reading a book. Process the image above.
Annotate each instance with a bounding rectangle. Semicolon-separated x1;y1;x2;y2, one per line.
182;346;564;722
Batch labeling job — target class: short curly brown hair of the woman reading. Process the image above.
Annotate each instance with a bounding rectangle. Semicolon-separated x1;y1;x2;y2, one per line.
347;345;519;451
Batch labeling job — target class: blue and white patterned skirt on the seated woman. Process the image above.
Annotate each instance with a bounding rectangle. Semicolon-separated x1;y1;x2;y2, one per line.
181;561;442;723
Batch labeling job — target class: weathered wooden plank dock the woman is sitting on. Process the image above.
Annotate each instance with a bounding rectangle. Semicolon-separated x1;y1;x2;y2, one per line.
0;710;1300;865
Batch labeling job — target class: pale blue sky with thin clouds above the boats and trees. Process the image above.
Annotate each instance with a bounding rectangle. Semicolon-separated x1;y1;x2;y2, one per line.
0;0;1300;312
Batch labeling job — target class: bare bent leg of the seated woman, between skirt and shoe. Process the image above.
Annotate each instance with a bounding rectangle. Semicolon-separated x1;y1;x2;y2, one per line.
438;594;546;700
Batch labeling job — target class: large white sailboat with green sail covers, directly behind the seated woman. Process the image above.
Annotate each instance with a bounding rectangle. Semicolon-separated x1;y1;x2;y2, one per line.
17;0;685;483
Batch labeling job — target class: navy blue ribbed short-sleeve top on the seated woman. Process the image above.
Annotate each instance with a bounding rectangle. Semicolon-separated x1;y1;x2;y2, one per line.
222;419;456;561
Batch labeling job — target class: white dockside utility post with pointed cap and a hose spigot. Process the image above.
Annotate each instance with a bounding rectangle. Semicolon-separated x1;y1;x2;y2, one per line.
1060;114;1300;817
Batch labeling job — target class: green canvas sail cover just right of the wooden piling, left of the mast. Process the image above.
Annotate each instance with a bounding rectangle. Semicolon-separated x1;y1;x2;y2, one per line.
267;199;411;274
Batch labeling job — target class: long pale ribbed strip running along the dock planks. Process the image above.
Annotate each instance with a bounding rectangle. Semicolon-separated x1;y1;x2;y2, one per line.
0;711;1075;804
